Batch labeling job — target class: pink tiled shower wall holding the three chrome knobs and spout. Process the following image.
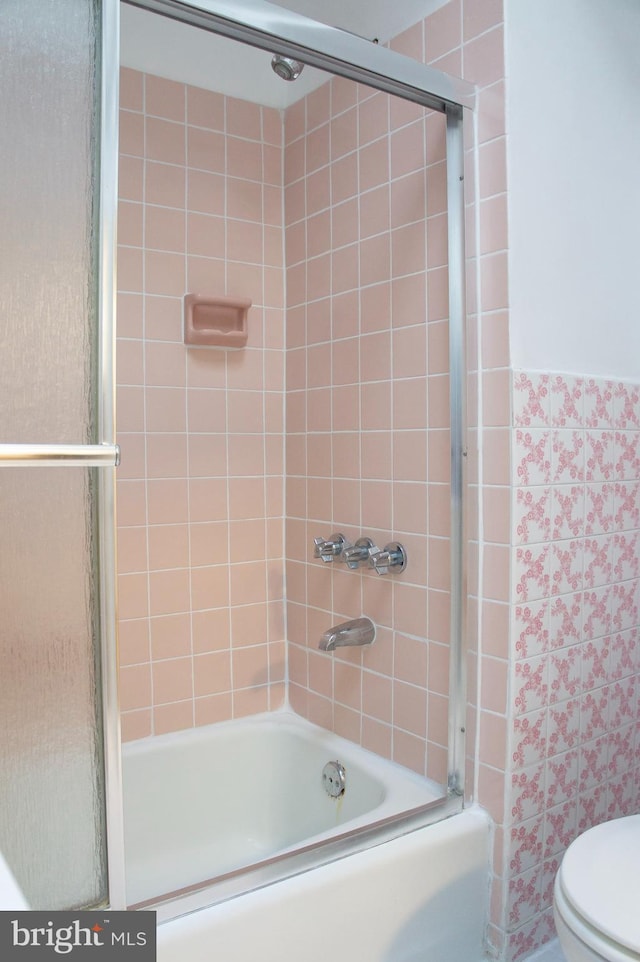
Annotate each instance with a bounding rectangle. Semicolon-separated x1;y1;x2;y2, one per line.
285;41;449;782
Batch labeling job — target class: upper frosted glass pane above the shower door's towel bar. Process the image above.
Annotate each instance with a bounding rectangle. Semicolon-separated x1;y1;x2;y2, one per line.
0;0;99;443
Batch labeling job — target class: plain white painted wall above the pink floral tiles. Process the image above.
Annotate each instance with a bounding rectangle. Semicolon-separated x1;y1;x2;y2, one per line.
505;0;640;381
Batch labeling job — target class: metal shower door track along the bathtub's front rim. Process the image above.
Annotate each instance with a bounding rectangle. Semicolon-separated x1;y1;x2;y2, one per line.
128;795;463;924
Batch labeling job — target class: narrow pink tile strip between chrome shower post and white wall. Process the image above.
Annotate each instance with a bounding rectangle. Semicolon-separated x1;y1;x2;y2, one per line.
456;0;511;840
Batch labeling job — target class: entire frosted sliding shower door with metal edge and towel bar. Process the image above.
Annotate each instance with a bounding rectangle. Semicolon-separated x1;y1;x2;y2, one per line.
0;0;119;909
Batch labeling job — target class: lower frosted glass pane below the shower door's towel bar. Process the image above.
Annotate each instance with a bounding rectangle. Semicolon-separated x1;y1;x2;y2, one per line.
0;467;106;909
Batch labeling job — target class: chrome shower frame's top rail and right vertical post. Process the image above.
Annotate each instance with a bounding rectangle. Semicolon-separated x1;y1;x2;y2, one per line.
118;0;475;918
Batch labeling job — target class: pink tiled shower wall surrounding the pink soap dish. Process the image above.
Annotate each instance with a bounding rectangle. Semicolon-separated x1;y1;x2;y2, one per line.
117;70;285;738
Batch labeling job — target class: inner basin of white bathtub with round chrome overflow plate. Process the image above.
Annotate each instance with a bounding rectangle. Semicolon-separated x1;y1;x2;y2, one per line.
123;711;443;905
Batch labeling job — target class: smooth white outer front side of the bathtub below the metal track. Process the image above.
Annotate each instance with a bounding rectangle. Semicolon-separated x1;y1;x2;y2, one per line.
157;808;489;962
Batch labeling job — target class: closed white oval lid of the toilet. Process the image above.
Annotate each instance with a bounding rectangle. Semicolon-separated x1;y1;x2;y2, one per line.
560;815;640;952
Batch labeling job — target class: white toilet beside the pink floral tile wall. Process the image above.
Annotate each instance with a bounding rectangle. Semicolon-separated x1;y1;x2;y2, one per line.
553;815;640;962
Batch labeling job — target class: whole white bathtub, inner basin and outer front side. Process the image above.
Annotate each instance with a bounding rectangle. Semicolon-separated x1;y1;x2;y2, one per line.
123;711;489;962
